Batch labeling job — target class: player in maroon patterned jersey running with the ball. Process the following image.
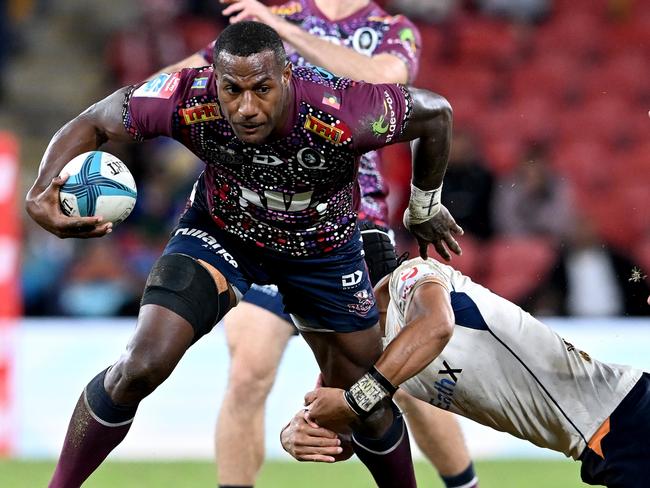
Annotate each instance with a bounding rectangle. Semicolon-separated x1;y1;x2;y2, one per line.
26;21;461;488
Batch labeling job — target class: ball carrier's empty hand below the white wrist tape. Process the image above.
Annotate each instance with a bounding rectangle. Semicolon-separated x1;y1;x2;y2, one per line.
404;205;464;261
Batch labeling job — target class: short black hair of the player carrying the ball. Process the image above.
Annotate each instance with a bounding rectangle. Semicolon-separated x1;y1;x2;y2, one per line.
212;20;287;67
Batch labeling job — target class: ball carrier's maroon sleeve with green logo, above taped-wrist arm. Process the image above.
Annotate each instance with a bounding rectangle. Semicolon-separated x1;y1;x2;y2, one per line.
342;82;411;154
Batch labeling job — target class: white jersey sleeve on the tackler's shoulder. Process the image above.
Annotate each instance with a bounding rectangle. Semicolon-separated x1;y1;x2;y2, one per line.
391;259;452;314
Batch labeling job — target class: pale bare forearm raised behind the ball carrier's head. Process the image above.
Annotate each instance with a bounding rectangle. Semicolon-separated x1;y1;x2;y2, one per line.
223;0;409;83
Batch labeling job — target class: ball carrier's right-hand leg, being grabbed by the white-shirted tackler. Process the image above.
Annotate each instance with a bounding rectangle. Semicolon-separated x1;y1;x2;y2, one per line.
274;232;415;488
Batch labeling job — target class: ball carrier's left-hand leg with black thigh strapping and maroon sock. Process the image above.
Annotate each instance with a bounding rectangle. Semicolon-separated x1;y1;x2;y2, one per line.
50;207;248;488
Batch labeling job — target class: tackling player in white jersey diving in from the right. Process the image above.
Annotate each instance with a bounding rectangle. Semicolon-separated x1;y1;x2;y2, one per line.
282;231;650;488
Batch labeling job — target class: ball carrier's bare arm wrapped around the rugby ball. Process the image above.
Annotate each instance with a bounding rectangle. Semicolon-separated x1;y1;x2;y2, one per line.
25;88;133;238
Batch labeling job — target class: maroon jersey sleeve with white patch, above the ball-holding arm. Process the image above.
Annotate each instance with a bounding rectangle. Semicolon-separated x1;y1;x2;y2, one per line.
122;70;190;140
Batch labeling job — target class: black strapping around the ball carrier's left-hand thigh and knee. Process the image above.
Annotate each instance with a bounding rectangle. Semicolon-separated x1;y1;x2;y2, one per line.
141;254;230;342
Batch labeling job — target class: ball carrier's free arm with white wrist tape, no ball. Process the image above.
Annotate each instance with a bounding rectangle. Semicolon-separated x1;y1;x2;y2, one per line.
399;88;463;261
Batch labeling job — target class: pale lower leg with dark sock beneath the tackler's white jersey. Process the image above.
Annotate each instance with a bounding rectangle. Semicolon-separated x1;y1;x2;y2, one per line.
395;390;478;488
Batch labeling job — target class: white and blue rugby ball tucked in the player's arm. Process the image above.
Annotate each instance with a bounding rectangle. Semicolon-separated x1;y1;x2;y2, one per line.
59;151;138;224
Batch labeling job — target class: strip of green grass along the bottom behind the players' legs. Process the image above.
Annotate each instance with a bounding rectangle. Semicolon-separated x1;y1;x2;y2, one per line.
0;460;587;488
